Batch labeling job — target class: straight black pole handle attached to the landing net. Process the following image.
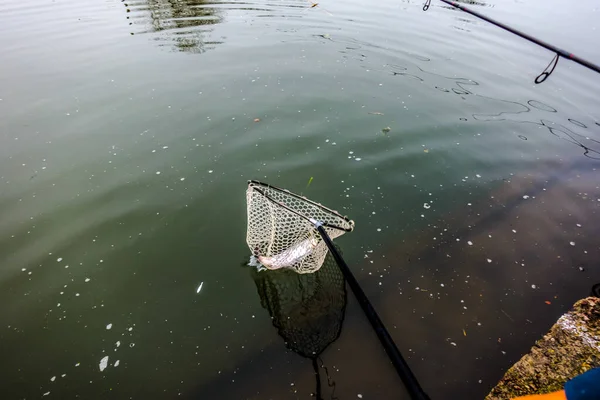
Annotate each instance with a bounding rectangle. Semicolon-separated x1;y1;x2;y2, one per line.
311;220;429;400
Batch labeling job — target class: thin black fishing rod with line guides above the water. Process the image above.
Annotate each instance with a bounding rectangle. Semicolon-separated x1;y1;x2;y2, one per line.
423;0;600;83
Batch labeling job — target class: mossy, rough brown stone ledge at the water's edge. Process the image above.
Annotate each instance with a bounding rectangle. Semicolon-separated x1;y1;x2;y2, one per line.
485;297;600;400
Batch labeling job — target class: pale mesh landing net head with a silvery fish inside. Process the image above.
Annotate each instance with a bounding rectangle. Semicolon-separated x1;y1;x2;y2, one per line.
246;181;354;274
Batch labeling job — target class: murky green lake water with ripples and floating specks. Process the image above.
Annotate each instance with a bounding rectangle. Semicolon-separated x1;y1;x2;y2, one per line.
0;0;600;399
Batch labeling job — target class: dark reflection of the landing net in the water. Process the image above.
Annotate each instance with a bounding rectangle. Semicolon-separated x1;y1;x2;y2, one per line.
251;254;346;399
